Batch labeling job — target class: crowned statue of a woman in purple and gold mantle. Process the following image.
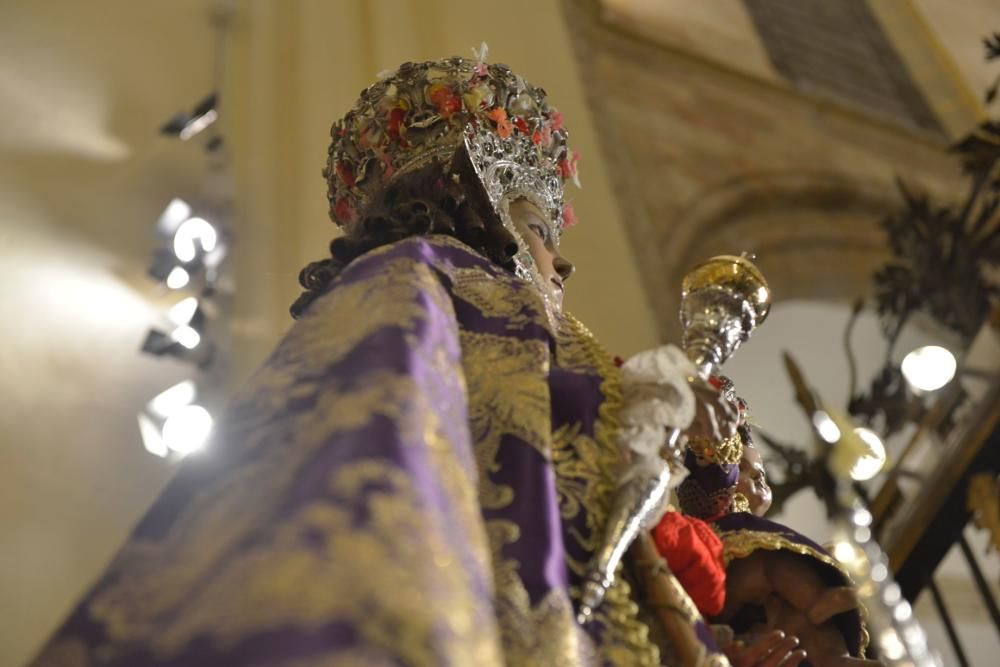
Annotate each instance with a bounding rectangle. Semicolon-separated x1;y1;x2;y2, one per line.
33;50;752;667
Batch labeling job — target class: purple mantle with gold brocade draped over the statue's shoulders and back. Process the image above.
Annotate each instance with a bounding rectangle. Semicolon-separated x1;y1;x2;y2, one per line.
34;237;724;667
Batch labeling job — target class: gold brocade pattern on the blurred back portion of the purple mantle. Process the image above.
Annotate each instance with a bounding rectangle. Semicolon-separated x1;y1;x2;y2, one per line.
37;241;503;667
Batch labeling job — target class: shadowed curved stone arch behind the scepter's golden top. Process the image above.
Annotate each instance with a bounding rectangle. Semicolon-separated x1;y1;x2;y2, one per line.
659;170;898;338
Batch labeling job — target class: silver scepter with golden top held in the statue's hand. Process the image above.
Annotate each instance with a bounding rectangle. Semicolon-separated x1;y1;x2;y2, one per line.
577;255;771;624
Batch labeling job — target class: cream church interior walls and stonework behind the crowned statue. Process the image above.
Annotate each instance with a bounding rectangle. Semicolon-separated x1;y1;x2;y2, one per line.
0;0;1000;665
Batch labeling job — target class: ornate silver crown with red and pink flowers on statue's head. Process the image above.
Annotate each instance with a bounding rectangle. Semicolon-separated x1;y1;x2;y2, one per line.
323;44;579;238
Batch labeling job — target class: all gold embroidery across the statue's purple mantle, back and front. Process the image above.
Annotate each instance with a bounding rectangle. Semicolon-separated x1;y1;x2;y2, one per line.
33;239;680;667
